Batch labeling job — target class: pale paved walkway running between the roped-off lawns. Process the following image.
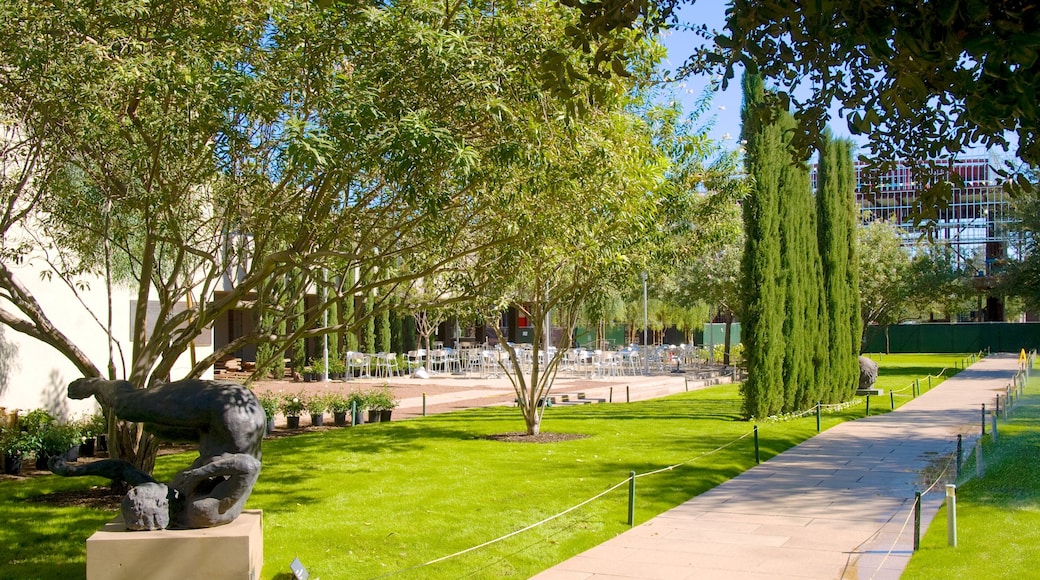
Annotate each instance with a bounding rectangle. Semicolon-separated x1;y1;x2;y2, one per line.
535;354;1018;580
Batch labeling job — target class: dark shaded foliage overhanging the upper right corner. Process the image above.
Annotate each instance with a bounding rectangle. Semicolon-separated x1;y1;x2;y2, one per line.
717;0;1040;196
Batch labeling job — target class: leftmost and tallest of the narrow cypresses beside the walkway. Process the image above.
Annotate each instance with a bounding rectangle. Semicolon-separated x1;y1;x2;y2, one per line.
740;73;790;418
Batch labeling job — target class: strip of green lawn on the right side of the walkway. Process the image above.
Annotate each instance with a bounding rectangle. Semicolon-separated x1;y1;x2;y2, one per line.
903;371;1040;579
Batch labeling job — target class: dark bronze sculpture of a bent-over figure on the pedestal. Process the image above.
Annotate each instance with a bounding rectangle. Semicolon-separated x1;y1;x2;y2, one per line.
51;378;267;530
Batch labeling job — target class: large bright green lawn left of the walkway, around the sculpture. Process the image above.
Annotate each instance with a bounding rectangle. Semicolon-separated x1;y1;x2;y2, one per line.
0;355;959;579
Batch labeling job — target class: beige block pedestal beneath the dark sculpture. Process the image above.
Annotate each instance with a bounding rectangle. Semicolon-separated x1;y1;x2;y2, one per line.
86;509;263;580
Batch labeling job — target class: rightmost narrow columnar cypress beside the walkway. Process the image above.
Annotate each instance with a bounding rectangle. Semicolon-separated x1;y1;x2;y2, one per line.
816;133;862;401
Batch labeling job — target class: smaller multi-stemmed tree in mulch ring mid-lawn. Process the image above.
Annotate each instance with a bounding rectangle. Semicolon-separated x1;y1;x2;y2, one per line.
470;95;665;434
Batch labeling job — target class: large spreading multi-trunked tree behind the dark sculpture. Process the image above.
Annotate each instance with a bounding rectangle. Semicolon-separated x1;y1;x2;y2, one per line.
0;0;603;471
